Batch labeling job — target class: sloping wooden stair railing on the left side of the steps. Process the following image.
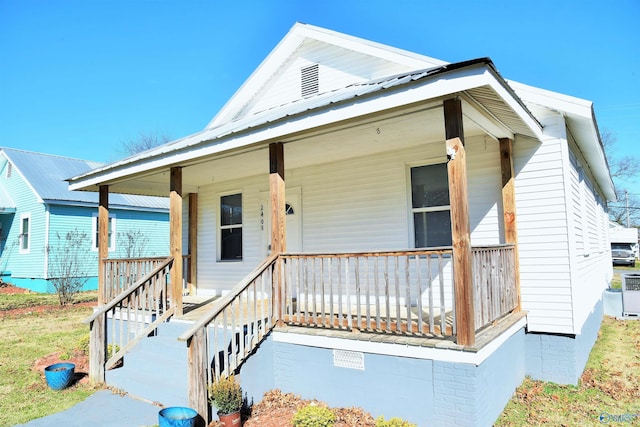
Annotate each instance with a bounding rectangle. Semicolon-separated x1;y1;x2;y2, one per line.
84;257;175;382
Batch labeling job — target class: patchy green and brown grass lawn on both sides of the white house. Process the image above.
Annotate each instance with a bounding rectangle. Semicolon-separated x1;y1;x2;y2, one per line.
0;294;640;426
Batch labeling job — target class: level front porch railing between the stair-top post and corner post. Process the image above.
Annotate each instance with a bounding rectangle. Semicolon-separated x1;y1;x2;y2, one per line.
281;248;456;336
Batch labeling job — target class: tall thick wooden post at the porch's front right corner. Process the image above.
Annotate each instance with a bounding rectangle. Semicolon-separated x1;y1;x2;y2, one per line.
444;99;475;346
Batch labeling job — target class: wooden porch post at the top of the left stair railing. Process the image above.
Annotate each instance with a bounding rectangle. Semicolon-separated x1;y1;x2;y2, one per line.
169;166;182;316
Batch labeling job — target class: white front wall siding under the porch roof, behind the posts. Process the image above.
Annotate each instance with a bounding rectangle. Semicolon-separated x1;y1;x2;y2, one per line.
192;138;501;293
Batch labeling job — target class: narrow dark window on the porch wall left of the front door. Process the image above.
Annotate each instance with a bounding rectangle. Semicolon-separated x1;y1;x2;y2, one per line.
220;194;242;261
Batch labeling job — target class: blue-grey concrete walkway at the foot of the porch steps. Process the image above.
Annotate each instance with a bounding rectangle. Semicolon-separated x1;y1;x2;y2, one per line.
18;390;162;427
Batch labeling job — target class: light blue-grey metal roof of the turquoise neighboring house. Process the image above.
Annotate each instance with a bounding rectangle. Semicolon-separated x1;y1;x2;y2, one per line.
0;147;169;210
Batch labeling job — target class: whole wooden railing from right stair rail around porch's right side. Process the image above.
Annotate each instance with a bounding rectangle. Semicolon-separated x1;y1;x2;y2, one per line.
179;245;517;417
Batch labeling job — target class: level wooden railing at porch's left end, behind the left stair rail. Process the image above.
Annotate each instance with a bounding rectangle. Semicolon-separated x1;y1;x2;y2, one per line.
103;257;166;303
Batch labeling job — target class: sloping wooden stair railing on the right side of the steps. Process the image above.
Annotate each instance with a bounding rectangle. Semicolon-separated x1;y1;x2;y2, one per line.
178;255;280;419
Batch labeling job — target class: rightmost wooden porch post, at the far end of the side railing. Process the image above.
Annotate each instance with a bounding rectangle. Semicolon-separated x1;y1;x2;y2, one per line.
499;138;521;312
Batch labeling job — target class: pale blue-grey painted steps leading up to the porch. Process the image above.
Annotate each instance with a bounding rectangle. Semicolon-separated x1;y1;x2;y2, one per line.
106;321;191;406
